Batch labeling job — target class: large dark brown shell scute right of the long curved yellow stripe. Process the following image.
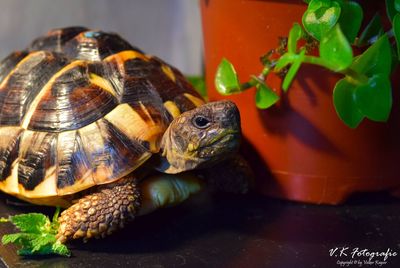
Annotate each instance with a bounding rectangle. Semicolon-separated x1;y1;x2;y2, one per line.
28;61;118;132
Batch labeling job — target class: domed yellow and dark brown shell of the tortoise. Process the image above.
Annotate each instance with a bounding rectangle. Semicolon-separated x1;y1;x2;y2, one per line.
0;27;204;199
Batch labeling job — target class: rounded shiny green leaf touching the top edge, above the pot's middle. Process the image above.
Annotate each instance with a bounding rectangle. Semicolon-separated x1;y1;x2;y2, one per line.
302;0;341;40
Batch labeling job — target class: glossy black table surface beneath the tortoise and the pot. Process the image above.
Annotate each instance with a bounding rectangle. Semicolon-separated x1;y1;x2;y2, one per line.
0;193;400;267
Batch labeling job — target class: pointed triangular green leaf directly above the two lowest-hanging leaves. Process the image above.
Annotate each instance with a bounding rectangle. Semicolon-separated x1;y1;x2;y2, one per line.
350;34;392;77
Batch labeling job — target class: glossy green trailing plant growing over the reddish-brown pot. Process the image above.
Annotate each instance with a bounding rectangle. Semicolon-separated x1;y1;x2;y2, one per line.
215;0;400;128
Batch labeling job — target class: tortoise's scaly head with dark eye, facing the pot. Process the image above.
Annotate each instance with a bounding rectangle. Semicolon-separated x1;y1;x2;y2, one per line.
158;101;240;173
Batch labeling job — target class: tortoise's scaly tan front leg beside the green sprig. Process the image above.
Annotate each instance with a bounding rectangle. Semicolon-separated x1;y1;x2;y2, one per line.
57;177;141;243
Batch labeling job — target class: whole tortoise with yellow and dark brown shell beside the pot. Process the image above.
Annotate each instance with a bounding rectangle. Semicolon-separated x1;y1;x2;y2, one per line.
0;27;249;242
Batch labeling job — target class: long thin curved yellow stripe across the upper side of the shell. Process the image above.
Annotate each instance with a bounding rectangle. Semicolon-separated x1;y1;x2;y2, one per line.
21;60;85;129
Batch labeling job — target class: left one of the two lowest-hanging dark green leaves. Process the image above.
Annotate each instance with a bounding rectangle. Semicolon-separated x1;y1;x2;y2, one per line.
333;79;364;128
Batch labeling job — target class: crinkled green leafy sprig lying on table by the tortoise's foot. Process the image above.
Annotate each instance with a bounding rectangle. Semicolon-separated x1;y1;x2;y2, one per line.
0;208;71;257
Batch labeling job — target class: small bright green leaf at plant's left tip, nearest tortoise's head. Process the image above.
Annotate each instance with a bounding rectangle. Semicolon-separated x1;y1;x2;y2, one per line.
215;58;241;95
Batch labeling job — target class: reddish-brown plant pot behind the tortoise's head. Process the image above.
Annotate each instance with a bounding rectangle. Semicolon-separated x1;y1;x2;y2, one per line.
201;0;400;204
